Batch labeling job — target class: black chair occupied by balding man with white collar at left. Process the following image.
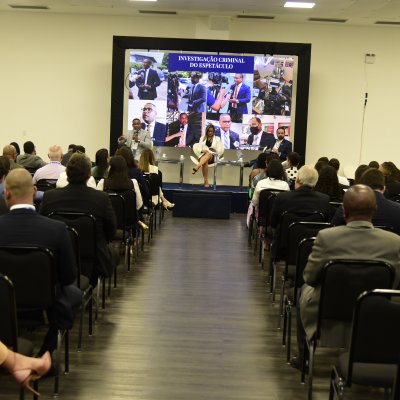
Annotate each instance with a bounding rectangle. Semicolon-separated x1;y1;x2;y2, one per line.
0;246;69;396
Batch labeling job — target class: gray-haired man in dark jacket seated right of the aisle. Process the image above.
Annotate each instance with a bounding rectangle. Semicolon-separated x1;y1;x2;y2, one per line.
271;165;332;228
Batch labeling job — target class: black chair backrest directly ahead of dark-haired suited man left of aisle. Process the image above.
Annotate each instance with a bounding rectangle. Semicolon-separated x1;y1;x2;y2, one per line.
108;190;137;232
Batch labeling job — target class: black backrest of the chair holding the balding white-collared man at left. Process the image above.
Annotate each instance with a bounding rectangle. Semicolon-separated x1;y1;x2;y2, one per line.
0;246;56;310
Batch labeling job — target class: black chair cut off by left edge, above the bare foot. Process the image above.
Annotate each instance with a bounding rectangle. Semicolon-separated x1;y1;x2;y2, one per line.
0;274;38;400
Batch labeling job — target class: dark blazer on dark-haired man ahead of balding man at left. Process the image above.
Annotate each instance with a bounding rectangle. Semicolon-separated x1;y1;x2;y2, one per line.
40;184;117;279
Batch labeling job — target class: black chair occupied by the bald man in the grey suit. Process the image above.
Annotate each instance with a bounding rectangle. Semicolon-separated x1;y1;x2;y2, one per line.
301;260;394;400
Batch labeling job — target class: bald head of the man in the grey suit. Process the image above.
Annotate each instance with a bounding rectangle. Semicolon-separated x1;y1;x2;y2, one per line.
343;185;376;222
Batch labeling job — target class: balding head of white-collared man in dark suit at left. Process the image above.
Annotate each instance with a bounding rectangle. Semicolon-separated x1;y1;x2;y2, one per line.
4;168;36;207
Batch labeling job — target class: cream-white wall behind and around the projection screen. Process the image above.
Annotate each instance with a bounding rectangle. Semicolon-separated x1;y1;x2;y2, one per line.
0;12;400;180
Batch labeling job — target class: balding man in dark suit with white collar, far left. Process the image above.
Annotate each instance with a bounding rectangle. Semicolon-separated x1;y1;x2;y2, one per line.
0;168;82;354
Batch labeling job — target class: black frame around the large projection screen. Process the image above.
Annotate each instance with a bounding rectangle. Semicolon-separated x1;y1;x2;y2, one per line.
110;36;311;160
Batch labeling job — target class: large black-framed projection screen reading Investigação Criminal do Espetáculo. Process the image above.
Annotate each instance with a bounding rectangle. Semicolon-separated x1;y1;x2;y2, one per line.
110;36;311;157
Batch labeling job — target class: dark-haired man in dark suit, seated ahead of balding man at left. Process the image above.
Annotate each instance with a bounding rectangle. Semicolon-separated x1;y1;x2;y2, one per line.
40;153;116;285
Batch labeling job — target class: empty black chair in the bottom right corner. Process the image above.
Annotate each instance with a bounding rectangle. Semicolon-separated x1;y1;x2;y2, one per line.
329;290;400;400
